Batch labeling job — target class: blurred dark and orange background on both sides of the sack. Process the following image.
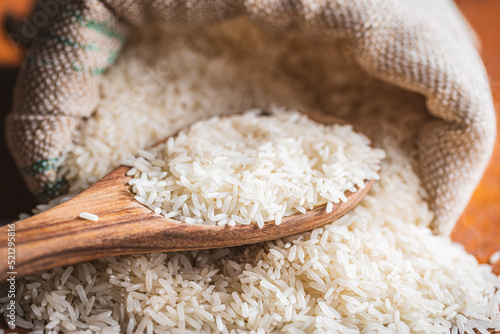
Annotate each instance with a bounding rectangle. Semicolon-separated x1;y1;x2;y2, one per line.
0;0;500;274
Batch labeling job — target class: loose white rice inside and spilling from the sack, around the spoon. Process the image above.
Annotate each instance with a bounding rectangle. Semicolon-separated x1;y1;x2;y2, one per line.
0;18;500;334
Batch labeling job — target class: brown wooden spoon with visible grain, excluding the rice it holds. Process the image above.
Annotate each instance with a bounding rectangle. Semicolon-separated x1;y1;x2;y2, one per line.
0;111;373;281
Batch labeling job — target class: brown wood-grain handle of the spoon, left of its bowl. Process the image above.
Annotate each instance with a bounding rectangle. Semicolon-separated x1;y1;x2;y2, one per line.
0;167;155;280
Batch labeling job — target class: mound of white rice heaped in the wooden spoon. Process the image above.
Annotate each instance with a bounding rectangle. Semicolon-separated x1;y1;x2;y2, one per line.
125;107;385;228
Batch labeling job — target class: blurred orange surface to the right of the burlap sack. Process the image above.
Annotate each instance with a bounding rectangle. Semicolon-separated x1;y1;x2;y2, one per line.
452;0;500;275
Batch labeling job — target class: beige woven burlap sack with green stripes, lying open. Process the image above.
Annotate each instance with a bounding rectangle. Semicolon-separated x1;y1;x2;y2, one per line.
7;0;496;234
